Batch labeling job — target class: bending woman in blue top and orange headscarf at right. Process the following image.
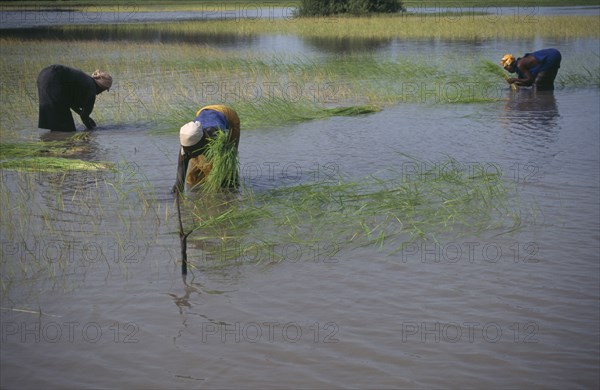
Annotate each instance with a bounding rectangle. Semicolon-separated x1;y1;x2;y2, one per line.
500;49;562;91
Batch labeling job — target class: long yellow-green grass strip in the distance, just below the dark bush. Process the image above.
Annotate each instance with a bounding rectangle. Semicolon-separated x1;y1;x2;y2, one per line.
48;14;600;39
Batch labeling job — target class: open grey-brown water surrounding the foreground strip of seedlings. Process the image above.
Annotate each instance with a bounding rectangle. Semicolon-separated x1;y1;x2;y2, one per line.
0;9;600;389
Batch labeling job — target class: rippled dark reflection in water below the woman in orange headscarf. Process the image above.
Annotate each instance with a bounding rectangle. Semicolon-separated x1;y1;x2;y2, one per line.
502;88;560;145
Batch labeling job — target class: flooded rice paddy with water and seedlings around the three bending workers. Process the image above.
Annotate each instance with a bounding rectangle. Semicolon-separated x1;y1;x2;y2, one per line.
0;6;600;388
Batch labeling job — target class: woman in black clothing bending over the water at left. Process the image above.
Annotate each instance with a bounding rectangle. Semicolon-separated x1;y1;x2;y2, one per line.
37;65;112;131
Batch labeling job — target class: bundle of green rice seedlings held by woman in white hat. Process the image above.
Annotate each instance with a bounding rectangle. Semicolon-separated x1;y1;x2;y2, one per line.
201;131;238;192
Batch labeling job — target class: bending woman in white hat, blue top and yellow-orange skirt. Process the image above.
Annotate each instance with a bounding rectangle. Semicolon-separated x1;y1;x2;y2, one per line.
172;105;240;192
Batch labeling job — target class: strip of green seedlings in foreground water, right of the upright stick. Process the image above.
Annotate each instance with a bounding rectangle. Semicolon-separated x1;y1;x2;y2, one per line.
184;159;521;263
